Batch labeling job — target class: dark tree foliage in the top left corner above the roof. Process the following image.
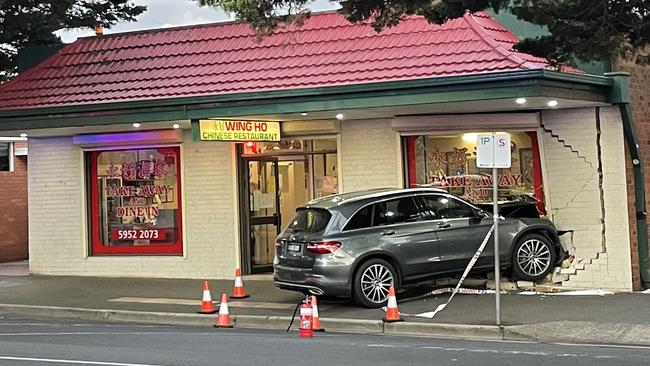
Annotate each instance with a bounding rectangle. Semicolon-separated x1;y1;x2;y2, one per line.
0;0;146;78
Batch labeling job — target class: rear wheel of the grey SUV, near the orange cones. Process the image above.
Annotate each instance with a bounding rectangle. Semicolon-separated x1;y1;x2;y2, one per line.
352;258;399;308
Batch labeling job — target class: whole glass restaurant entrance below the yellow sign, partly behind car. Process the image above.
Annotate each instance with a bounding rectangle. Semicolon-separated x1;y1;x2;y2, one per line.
237;138;338;274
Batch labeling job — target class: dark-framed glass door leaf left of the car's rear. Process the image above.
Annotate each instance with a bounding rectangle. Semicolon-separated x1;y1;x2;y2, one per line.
242;158;281;273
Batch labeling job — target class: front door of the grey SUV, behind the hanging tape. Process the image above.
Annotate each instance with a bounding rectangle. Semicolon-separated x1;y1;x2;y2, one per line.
421;194;494;272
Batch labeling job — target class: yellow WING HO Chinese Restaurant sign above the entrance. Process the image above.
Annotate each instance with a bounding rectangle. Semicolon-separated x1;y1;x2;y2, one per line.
199;119;280;141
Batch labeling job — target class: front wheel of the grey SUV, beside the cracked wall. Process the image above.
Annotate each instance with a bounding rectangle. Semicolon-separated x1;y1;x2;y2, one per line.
512;234;556;281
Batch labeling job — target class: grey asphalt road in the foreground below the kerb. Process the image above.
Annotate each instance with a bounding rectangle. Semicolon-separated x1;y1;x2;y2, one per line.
0;317;650;366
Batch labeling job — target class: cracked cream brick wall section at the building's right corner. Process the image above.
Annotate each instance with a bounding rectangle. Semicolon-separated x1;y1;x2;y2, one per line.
542;107;632;290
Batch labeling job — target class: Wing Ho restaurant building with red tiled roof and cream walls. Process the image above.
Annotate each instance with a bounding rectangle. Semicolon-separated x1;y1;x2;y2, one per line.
0;13;632;291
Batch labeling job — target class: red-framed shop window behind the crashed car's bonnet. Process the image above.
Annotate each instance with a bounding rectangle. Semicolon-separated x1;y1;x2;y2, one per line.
404;132;545;215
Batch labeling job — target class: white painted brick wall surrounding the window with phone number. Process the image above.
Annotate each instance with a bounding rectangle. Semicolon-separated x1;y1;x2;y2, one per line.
28;131;239;278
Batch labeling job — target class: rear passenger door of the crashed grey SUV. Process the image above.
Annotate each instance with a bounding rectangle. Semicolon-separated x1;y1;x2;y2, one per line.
372;196;440;277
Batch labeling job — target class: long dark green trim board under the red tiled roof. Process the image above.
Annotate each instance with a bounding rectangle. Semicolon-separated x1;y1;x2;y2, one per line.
0;70;613;131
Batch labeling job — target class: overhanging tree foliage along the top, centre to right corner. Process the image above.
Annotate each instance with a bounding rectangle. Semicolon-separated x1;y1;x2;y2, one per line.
196;0;650;62
